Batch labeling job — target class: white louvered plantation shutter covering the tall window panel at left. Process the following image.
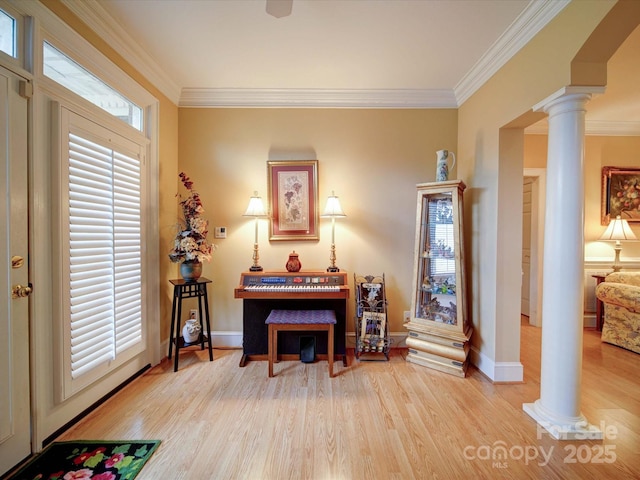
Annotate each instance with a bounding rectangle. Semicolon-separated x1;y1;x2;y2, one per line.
68;132;142;379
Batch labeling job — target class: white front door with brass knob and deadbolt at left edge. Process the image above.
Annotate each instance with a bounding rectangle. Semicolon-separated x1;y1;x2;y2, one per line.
0;67;31;475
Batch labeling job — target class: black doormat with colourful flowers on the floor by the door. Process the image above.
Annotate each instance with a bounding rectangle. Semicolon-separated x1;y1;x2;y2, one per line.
7;440;160;480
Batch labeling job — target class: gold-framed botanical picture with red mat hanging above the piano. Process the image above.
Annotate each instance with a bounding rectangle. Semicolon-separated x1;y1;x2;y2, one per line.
267;160;319;241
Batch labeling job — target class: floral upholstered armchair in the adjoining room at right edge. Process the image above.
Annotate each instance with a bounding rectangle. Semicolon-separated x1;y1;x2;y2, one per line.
596;272;640;353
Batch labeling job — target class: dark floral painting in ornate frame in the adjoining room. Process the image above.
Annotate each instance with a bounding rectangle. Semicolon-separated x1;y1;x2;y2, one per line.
601;167;640;225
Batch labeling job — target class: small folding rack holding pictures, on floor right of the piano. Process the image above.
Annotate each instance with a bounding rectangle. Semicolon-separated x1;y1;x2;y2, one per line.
353;273;391;360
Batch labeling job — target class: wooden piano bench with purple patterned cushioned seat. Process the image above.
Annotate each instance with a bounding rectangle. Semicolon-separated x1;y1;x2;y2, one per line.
265;310;336;378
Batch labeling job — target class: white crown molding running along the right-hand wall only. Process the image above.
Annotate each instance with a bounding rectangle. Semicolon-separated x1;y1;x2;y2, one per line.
454;0;571;105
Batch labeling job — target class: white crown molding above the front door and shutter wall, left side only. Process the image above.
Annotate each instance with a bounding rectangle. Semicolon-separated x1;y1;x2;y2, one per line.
61;0;180;105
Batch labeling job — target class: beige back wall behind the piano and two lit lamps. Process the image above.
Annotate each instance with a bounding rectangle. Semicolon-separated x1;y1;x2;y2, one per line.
175;108;457;332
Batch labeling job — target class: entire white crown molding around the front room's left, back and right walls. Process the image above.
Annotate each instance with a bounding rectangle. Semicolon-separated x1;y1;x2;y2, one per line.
61;0;570;108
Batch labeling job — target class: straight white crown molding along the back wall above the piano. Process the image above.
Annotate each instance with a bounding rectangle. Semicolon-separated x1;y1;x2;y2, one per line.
179;88;458;108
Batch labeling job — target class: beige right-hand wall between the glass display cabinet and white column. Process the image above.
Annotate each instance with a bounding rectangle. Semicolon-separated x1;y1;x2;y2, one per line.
458;1;615;376
